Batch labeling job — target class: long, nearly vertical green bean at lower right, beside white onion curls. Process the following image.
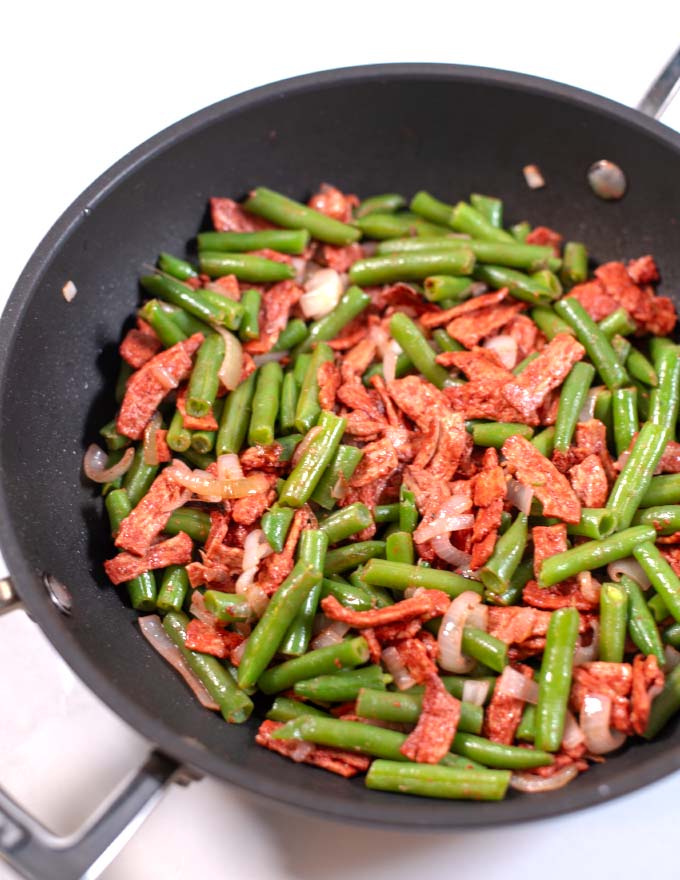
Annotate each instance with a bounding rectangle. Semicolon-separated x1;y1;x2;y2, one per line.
535;608;579;752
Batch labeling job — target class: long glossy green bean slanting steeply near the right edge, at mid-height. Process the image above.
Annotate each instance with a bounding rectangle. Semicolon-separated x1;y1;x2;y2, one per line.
606;422;668;529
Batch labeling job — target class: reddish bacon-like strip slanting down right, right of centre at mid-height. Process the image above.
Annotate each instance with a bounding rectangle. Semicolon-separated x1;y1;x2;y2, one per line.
502;434;581;523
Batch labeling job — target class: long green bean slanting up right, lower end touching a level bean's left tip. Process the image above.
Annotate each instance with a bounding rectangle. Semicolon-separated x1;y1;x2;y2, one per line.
238;562;320;687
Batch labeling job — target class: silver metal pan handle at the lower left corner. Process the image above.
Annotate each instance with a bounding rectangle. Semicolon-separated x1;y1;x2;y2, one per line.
0;578;190;880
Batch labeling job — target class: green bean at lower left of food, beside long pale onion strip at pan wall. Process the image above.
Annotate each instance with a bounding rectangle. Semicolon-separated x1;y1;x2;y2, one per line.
163;611;253;724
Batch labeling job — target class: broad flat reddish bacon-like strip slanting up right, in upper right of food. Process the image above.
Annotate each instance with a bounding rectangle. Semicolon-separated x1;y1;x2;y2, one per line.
503;333;586;418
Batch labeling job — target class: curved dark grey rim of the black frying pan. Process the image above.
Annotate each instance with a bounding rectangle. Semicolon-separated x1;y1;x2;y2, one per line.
0;63;680;831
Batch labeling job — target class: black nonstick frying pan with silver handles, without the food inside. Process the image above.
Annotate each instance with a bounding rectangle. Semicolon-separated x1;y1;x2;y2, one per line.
0;53;680;880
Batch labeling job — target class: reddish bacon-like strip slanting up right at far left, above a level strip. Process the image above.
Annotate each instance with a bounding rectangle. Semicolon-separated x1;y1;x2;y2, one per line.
116;470;191;556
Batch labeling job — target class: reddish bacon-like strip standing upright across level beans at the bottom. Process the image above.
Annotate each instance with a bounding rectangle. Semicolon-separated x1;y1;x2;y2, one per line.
399;673;460;764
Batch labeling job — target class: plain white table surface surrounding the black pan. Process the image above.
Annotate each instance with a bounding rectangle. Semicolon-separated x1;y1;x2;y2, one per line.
0;0;680;880
